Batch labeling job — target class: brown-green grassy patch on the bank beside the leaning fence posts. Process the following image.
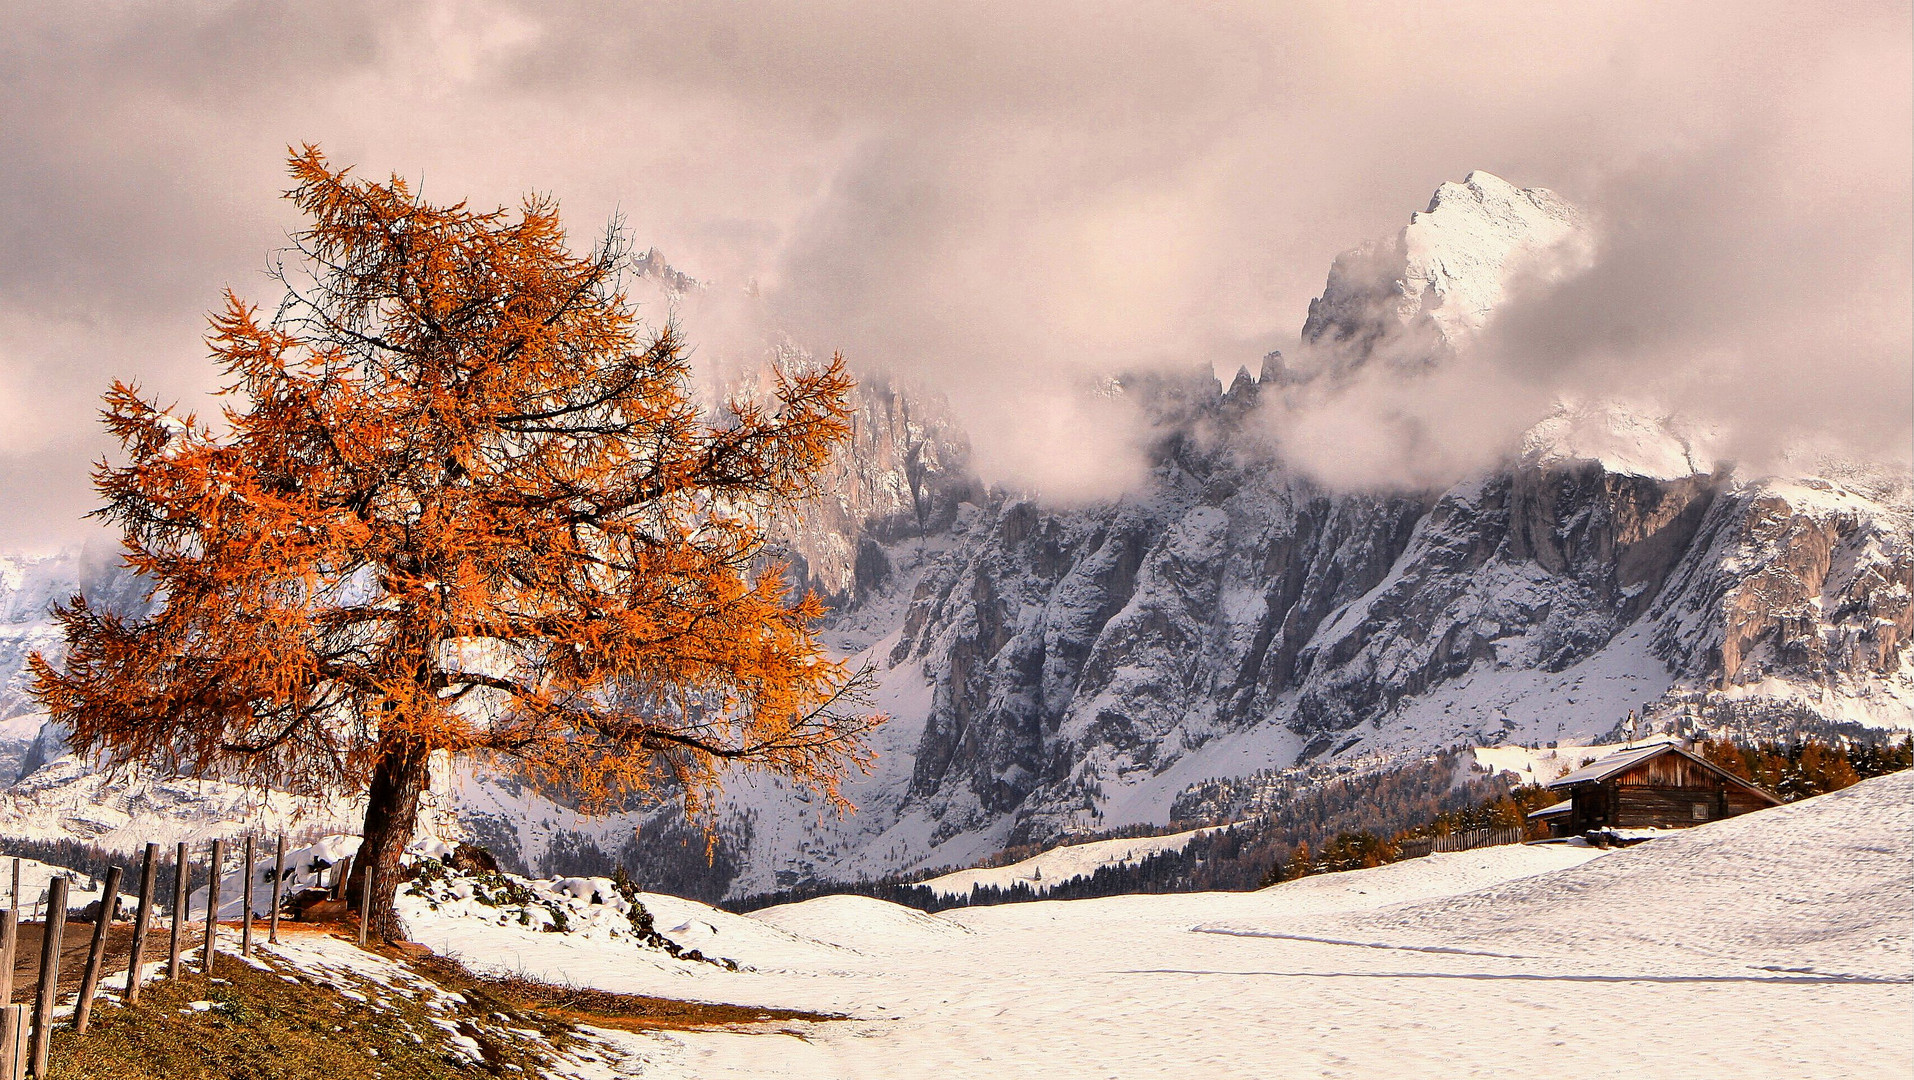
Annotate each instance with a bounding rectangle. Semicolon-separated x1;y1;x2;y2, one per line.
50;942;578;1080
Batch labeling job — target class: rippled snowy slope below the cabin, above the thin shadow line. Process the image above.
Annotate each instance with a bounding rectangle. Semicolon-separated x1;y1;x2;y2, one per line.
1263;772;1914;982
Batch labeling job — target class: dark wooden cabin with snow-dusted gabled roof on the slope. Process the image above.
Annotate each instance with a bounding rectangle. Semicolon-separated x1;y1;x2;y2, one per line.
1529;743;1782;837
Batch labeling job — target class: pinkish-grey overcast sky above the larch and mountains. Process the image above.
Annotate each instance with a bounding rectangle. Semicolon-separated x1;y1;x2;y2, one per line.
0;0;1914;550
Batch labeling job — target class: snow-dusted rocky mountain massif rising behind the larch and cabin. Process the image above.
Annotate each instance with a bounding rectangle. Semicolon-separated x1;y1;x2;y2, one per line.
0;172;1914;894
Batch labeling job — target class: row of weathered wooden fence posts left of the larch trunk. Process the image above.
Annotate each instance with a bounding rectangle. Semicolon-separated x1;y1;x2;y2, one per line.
0;835;361;1080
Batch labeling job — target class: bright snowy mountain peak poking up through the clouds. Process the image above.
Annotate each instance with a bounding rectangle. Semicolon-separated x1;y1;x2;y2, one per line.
1303;170;1589;373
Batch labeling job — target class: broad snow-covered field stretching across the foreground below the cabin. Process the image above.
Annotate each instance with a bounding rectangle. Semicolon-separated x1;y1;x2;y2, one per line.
388;774;1914;1080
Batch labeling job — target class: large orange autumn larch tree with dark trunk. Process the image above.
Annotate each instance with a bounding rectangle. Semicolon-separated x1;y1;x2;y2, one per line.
33;146;882;938
